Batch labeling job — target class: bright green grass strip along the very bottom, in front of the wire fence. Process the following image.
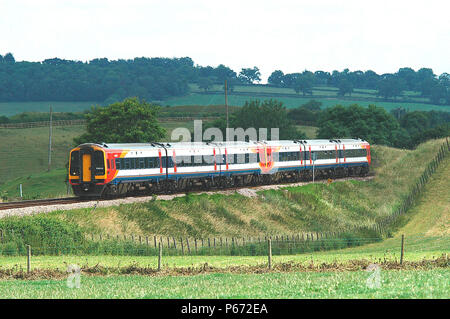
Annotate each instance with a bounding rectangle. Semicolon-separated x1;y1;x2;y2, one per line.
0;269;450;299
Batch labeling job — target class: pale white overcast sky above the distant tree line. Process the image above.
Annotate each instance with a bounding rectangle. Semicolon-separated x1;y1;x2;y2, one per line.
0;0;450;82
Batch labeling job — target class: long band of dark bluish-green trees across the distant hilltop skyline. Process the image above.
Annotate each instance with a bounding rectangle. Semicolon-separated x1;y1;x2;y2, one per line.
0;53;450;105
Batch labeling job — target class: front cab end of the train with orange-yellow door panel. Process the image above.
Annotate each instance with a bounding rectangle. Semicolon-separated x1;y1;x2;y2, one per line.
69;144;107;197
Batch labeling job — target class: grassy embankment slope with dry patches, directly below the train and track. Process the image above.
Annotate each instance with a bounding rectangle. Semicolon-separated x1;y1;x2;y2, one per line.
16;140;445;237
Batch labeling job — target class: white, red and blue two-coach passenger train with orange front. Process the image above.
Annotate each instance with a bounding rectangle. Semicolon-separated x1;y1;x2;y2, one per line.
69;138;371;197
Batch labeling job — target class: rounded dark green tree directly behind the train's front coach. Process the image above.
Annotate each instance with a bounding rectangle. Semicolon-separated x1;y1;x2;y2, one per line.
74;97;166;144
